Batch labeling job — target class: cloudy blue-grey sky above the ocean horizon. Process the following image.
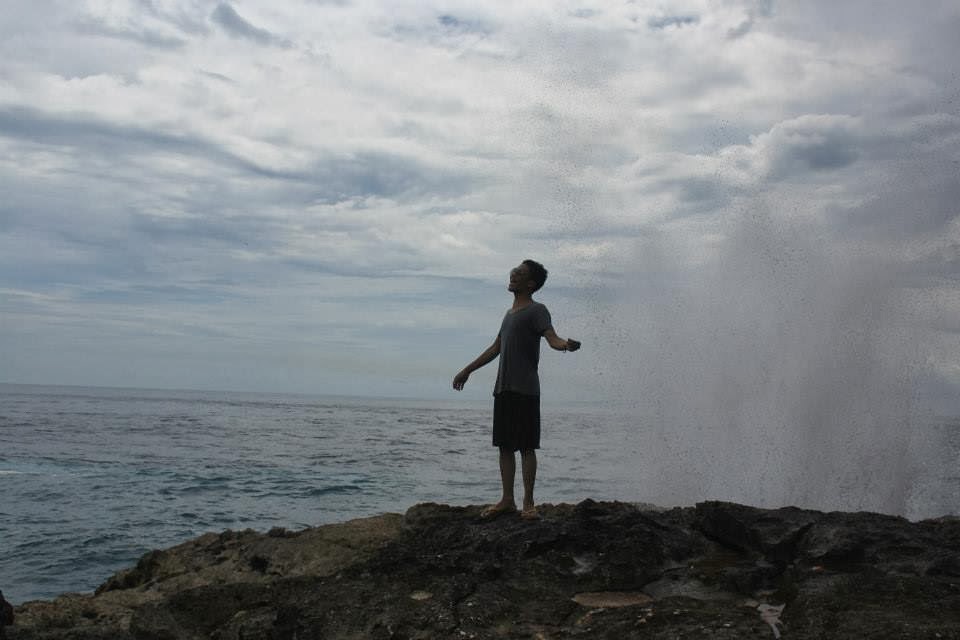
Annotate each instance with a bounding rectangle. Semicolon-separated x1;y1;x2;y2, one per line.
0;0;960;410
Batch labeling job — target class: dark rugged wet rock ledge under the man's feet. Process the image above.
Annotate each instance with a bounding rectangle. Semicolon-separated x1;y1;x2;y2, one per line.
6;500;960;640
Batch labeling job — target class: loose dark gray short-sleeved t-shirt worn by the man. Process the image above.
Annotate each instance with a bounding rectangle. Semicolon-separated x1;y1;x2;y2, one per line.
493;302;553;396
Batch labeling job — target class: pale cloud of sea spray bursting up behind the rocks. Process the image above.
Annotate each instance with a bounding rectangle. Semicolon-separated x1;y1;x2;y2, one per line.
604;204;955;517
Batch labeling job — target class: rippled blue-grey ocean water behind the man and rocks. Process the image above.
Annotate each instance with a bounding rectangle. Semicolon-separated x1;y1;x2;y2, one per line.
0;384;960;604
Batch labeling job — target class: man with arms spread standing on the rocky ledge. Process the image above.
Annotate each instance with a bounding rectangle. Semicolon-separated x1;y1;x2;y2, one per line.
453;260;580;520
